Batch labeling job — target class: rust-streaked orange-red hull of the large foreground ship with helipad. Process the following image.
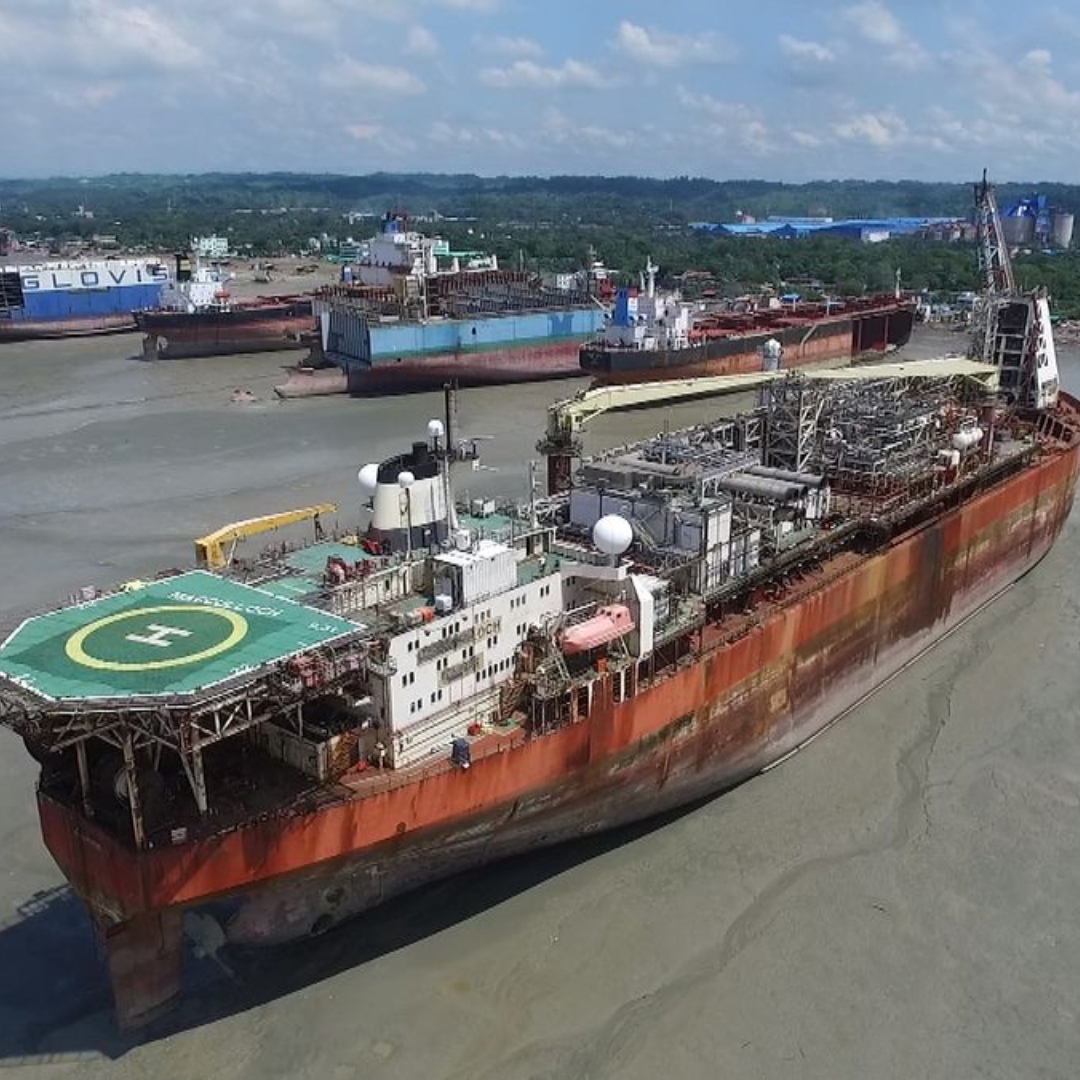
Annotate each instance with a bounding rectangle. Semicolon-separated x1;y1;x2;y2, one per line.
39;406;1080;1023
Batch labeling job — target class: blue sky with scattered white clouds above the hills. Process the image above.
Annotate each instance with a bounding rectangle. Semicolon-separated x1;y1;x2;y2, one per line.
0;0;1080;183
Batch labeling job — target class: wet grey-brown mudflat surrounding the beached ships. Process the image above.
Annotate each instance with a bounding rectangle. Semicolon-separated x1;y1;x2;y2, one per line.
0;324;1080;1080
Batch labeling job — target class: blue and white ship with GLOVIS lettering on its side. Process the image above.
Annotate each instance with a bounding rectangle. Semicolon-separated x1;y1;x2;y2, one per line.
0;258;173;342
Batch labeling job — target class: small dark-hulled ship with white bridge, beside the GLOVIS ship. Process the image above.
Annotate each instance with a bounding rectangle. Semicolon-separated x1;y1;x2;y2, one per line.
135;255;314;360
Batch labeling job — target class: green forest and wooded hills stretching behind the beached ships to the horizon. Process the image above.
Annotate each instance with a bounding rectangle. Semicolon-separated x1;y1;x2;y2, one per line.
6;173;1080;318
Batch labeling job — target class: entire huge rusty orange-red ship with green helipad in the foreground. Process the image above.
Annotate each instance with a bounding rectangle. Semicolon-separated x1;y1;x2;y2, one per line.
0;170;1080;1027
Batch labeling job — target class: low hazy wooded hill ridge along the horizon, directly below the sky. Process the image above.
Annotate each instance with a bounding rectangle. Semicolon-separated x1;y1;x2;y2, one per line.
6;173;1080;227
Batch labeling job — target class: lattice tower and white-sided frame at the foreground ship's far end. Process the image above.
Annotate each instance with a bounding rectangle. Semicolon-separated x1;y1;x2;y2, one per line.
968;171;1058;408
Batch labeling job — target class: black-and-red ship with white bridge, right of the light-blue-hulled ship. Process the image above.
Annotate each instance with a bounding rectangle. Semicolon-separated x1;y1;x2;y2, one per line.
580;261;917;386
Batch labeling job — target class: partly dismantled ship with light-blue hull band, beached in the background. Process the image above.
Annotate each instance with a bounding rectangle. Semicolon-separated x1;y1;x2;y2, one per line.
275;213;611;397
